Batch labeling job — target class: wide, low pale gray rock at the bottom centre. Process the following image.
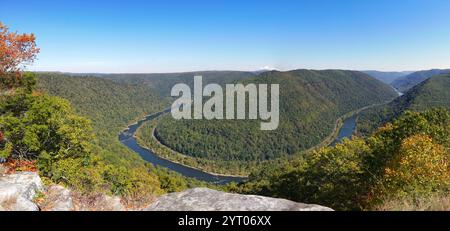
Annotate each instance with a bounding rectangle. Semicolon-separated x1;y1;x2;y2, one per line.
145;188;333;211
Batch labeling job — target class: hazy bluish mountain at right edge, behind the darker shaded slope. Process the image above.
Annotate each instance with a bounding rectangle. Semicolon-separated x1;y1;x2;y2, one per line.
391;69;450;93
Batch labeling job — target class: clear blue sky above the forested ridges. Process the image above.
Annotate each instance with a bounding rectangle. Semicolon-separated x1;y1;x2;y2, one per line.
0;0;450;72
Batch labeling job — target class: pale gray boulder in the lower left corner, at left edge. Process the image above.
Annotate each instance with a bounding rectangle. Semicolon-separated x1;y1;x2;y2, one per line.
0;172;44;211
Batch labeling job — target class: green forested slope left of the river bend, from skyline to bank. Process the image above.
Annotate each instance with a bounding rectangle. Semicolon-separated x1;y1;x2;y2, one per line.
33;73;209;196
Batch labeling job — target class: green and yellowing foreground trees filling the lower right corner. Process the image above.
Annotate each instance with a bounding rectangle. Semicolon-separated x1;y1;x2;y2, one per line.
237;109;450;211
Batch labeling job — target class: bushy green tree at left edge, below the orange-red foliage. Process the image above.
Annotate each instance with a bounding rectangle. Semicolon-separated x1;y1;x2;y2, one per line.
0;94;93;163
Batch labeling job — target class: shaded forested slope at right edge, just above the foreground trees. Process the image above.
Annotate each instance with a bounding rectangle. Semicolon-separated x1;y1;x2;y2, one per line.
358;74;450;135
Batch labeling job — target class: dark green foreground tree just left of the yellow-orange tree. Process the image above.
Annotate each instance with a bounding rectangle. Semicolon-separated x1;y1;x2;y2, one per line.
275;139;370;210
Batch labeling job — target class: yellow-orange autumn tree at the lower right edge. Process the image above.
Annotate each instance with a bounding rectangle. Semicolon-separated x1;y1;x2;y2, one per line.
378;135;450;201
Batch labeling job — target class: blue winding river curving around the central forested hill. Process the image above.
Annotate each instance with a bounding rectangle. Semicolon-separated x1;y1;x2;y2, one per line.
119;109;356;185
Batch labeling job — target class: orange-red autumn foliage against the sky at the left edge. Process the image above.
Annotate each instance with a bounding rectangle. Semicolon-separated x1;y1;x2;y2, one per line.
0;22;39;88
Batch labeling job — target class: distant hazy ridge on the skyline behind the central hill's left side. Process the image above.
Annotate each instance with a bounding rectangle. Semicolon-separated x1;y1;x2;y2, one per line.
97;71;255;96
